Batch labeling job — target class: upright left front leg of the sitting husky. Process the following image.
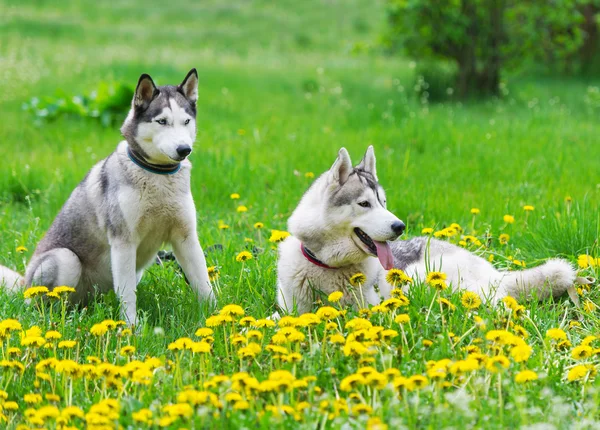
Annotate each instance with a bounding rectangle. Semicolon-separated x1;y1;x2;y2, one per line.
110;242;137;325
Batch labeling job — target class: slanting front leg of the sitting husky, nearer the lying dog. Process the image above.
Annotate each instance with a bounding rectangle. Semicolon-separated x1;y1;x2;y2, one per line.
171;229;215;301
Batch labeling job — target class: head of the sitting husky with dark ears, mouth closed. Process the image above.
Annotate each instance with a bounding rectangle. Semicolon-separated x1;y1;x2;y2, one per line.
121;69;198;164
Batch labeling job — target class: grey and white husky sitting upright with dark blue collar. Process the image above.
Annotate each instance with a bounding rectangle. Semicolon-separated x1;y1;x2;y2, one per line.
0;69;213;324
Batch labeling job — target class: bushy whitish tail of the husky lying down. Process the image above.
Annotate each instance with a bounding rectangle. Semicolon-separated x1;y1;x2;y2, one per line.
498;258;576;300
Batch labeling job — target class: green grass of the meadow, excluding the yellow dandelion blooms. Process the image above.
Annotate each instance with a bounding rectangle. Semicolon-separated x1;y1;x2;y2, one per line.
0;0;600;428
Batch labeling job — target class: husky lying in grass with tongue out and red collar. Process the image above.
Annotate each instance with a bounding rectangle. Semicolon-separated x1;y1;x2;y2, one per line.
275;146;575;317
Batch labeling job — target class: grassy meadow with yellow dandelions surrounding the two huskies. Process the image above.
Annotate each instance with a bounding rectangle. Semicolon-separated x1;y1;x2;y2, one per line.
0;0;600;429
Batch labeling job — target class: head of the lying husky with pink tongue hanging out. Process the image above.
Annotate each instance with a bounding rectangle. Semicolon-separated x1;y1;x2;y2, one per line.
289;146;405;269
